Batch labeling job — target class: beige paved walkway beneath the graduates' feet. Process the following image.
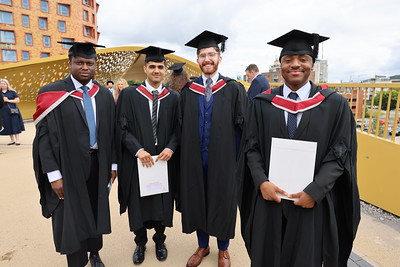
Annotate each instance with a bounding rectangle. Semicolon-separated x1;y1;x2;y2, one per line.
0;123;400;267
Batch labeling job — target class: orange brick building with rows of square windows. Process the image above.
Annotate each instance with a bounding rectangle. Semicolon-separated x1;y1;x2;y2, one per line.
0;0;100;65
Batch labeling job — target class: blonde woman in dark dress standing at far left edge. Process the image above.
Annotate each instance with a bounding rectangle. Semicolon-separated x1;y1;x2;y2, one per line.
0;79;25;146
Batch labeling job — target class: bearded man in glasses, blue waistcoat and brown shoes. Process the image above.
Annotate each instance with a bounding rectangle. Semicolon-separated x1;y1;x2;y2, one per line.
179;31;248;267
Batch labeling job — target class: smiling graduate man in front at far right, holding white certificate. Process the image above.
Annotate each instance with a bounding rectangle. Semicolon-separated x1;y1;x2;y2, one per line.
240;30;360;267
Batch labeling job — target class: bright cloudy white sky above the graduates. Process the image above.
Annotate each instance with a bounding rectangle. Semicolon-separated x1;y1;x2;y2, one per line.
97;0;400;83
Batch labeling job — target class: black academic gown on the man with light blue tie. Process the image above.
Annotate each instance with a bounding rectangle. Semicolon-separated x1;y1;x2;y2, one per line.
33;77;115;254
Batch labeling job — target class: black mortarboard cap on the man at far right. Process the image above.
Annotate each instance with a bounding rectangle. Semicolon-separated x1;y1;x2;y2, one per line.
268;30;329;62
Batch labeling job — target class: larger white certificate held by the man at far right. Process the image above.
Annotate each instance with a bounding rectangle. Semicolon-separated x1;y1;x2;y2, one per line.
268;138;317;200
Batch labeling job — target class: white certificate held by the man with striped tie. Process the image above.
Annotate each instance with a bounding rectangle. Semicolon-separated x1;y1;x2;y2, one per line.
137;156;169;197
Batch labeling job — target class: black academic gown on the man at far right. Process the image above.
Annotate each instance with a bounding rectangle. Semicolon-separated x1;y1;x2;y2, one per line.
241;81;360;267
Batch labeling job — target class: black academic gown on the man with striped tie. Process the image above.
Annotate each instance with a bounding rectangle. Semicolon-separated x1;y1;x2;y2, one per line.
117;83;179;231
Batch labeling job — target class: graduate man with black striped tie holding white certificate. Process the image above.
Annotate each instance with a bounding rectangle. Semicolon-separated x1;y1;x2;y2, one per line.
117;46;179;264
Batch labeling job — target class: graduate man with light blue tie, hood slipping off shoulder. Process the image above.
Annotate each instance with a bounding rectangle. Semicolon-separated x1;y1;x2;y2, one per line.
33;42;116;267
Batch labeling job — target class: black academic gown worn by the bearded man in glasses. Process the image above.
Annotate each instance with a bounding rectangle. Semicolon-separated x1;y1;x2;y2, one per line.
179;76;248;240
